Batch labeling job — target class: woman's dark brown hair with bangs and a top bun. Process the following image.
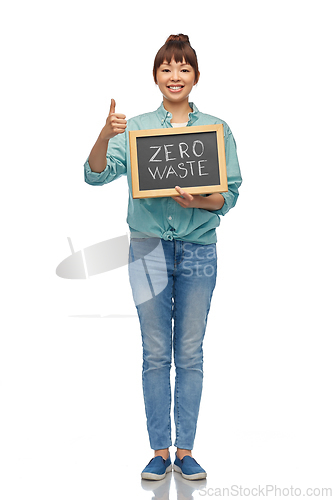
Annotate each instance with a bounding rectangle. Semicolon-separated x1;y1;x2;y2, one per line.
153;33;200;83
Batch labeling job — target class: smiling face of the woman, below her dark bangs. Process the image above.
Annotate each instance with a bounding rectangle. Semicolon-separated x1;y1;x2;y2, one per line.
156;59;197;102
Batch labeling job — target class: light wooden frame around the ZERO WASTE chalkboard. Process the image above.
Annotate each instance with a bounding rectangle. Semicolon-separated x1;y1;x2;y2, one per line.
129;123;228;198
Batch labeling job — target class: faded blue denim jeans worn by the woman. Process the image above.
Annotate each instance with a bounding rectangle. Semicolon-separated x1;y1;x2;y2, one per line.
128;238;217;450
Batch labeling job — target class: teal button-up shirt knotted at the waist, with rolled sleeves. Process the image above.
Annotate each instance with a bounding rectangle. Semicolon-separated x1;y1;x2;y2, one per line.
84;103;242;245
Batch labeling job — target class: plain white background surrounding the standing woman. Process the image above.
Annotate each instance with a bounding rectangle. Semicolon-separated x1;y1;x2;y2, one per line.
0;0;333;500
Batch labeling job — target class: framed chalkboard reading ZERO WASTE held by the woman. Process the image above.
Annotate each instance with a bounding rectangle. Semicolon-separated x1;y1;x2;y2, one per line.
129;124;228;198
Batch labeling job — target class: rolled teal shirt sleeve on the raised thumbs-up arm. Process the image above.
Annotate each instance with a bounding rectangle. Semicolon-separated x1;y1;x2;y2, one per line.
84;132;127;186
